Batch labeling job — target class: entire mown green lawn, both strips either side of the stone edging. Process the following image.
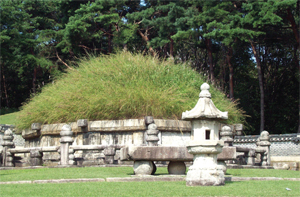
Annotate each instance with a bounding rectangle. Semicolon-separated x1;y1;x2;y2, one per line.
0;167;300;197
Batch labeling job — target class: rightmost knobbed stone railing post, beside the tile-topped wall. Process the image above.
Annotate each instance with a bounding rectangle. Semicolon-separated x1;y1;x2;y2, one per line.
257;131;271;166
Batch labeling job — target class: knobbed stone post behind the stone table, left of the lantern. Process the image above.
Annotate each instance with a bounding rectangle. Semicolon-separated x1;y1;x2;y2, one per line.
145;116;159;146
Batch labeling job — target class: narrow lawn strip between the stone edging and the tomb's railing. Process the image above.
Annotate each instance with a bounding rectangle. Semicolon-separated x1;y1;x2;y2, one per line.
0;167;300;181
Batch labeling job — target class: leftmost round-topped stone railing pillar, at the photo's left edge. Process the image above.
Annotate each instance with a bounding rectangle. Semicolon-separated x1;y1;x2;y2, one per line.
2;129;15;167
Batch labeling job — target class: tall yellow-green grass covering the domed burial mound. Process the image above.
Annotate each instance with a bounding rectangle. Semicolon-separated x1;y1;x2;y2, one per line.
17;52;244;129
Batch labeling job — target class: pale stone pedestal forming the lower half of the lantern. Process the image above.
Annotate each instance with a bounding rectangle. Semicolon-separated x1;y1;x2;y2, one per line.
186;140;225;186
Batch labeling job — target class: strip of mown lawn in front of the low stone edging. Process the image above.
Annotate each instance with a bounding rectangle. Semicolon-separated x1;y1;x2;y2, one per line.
0;181;300;197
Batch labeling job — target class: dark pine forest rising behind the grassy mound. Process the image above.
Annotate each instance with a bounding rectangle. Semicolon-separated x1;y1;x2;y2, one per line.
0;0;300;134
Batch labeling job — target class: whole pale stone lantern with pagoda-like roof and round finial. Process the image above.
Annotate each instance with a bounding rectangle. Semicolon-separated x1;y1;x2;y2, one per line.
182;83;228;186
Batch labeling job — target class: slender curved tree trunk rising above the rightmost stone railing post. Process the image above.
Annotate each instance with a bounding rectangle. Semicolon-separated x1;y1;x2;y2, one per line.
250;40;265;132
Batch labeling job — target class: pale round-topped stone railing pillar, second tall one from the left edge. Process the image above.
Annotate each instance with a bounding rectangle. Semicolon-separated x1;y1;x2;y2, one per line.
60;124;74;166
